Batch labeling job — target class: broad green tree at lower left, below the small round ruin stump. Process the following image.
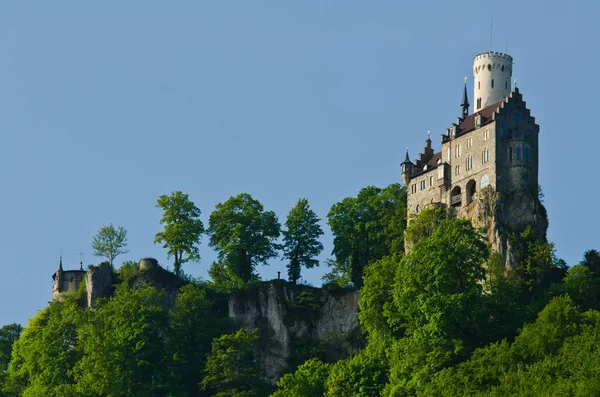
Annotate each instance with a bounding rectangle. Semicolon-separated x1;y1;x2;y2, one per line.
74;283;173;397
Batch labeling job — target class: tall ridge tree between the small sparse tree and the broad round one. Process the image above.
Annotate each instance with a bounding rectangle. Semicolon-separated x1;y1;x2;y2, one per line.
154;190;204;276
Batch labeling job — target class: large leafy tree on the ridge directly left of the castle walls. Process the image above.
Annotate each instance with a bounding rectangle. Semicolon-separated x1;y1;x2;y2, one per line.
327;184;406;287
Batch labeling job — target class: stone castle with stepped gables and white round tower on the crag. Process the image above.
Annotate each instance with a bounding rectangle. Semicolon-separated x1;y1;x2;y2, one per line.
401;51;548;265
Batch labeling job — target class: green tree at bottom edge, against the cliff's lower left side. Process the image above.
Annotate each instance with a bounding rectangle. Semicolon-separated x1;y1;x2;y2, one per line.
202;329;264;397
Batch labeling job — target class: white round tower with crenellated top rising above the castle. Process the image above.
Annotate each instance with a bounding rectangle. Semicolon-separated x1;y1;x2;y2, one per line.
473;52;512;113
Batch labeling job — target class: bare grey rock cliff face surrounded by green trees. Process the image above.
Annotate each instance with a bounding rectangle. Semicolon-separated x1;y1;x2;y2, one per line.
229;280;363;384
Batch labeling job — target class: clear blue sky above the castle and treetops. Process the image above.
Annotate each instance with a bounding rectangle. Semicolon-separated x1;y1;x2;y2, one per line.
0;0;600;325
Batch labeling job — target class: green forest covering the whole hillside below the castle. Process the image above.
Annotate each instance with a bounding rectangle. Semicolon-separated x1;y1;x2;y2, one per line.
0;184;600;397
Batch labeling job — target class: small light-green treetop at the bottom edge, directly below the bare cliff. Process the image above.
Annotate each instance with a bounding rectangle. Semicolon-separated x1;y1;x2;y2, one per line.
271;358;331;397
